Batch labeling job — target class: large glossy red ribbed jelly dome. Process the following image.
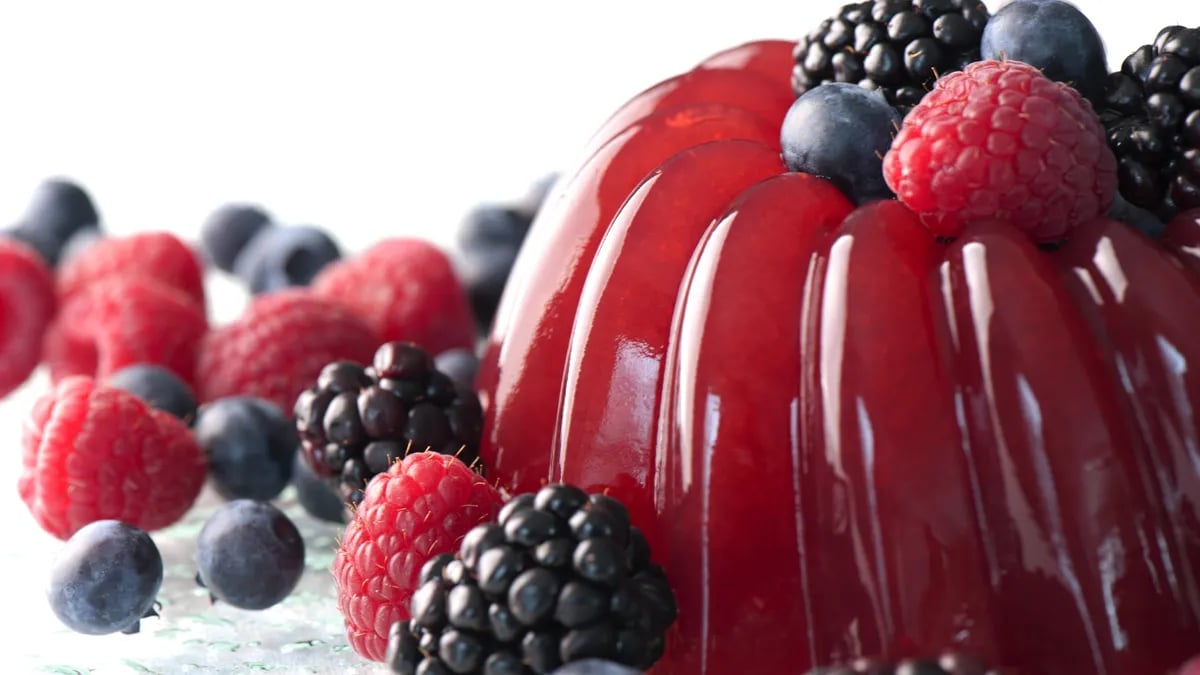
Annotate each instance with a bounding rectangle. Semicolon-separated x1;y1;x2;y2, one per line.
479;42;1200;675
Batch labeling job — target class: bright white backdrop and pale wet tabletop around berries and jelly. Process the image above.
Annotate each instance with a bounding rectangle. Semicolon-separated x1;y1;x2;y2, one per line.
0;0;1180;674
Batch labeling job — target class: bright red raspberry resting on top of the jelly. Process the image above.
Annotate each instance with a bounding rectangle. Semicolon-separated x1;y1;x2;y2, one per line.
883;61;1117;241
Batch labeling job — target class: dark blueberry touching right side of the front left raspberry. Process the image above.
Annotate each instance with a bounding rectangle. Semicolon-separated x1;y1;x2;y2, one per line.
196;396;300;500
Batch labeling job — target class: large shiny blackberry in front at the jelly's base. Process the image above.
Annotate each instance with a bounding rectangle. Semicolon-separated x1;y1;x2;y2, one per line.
388;484;677;675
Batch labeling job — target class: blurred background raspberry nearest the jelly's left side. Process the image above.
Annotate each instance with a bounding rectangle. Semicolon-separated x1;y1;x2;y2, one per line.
312;239;475;356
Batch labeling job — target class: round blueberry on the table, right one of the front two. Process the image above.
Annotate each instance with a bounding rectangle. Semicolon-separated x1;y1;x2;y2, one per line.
196;500;305;609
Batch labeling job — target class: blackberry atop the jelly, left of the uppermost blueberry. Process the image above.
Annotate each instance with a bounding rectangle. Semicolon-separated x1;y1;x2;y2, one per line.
792;0;990;114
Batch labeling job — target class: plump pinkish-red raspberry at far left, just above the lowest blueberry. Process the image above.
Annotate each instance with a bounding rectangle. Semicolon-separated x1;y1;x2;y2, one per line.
18;377;205;539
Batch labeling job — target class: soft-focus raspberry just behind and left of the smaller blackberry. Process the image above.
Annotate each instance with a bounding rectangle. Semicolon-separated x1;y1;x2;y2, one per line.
197;289;376;411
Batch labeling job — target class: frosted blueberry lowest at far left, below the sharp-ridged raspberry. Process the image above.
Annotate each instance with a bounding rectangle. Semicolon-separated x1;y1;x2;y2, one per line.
47;520;162;635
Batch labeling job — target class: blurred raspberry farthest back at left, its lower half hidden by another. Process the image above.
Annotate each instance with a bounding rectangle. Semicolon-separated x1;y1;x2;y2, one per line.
59;232;204;307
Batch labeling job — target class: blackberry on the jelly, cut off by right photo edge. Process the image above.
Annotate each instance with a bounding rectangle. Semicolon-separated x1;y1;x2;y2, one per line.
1100;25;1200;221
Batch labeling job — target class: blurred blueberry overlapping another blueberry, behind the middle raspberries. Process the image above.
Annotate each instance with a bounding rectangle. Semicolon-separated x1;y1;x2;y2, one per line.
234;225;342;294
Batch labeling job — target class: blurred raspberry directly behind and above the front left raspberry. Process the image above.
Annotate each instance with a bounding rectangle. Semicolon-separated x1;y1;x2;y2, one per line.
46;276;208;387
